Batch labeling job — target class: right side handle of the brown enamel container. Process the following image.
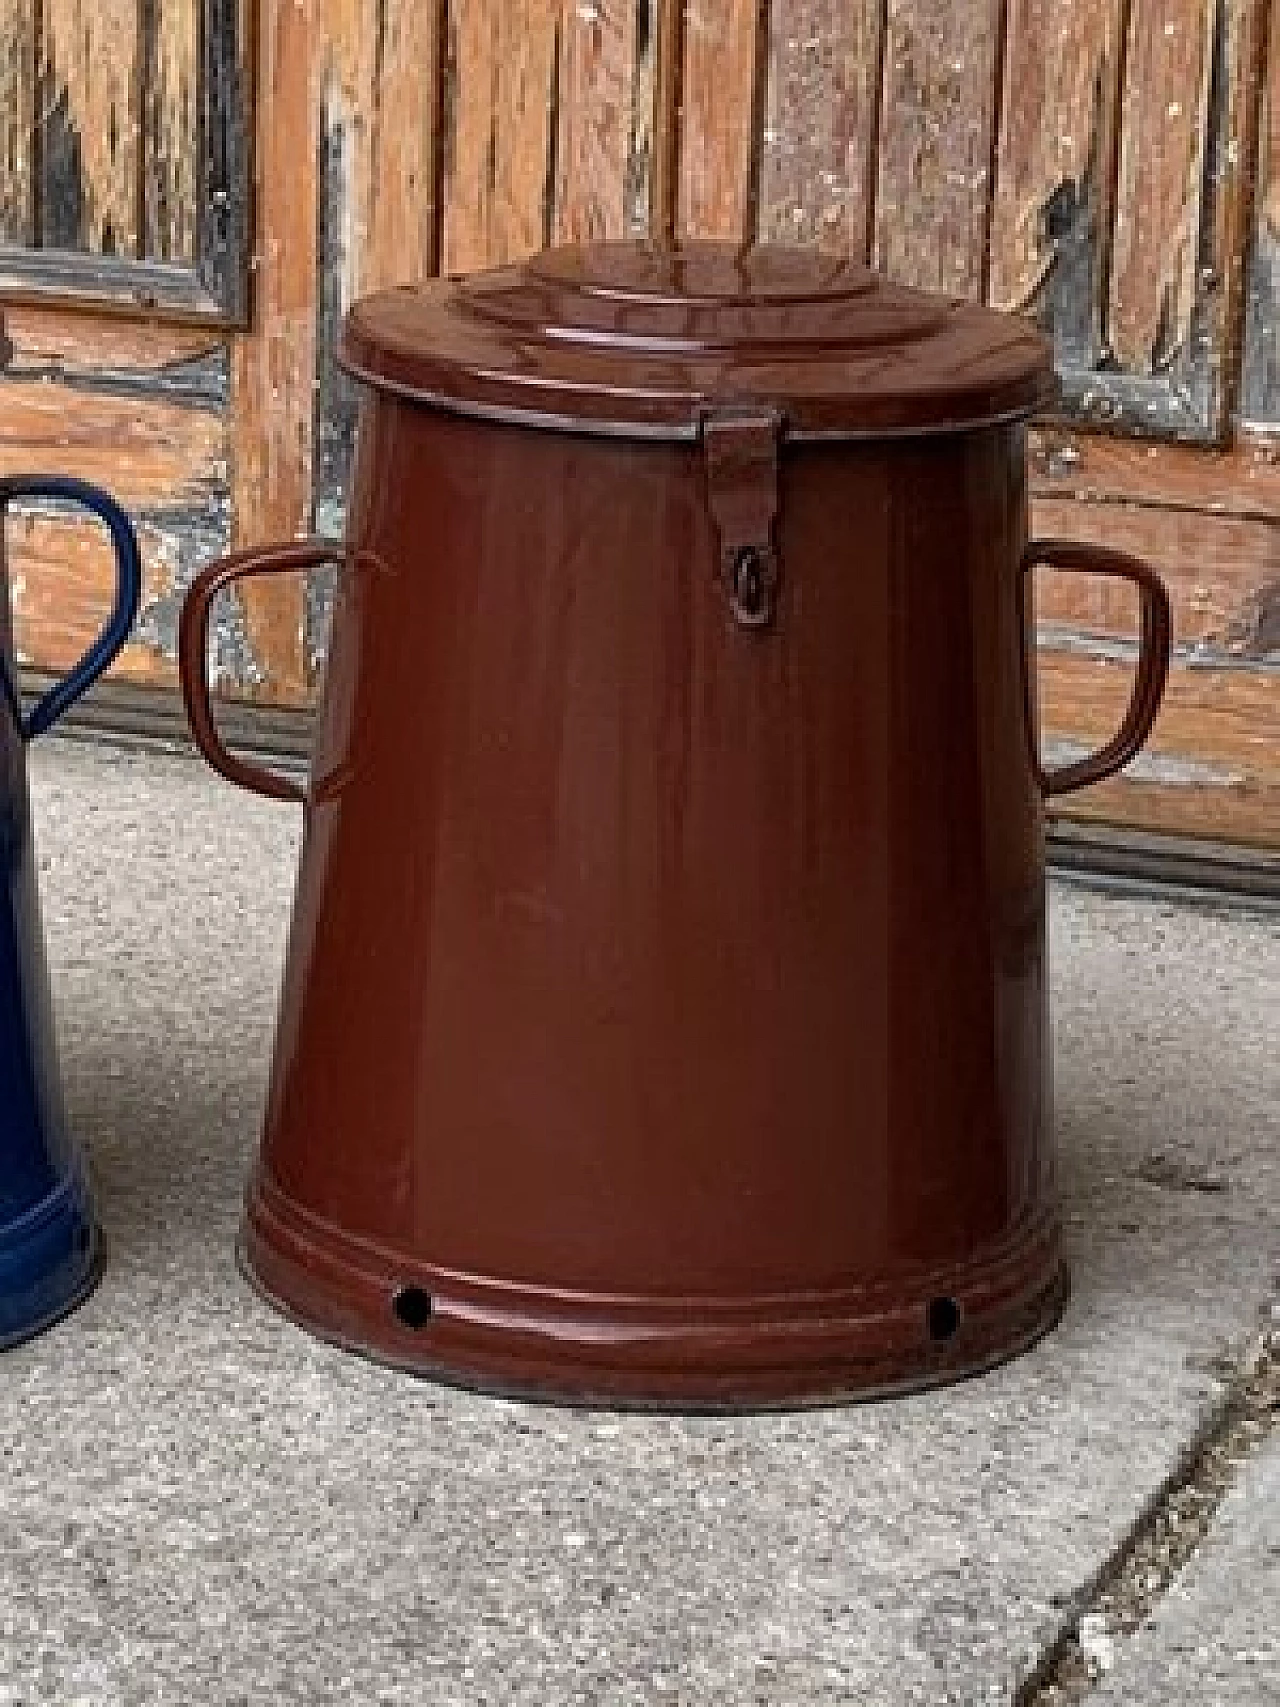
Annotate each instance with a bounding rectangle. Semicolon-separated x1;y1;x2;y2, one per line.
1017;539;1172;797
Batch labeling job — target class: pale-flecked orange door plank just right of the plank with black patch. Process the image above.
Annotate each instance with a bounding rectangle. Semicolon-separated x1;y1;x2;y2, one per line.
1108;0;1219;374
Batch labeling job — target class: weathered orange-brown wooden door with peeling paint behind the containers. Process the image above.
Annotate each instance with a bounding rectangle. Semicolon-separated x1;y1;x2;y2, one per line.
0;0;1280;850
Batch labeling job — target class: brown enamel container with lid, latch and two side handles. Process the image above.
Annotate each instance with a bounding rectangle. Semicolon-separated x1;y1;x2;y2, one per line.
183;242;1169;1407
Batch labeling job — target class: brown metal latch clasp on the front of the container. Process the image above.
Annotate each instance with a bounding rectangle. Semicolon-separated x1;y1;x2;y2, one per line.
701;410;782;628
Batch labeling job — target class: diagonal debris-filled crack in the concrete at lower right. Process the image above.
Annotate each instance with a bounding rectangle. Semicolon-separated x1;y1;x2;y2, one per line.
1014;1302;1280;1707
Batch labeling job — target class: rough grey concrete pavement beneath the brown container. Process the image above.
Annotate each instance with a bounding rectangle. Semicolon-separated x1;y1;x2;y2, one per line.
0;741;1280;1707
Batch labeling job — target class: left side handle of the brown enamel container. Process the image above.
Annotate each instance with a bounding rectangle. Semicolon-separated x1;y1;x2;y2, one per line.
177;539;345;806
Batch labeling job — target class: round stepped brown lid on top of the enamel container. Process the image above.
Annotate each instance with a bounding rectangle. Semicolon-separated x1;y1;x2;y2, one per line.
338;239;1056;439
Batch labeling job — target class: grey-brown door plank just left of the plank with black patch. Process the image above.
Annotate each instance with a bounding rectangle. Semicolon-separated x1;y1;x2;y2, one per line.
876;0;1000;297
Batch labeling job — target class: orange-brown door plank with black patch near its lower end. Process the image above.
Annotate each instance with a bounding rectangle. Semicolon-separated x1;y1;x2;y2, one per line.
988;0;1123;353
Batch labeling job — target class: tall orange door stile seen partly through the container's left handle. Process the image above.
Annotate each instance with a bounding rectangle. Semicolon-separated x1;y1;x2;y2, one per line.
230;0;321;702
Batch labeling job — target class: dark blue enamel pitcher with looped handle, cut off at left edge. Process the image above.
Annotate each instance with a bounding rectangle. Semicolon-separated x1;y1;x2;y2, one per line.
0;478;142;1349
